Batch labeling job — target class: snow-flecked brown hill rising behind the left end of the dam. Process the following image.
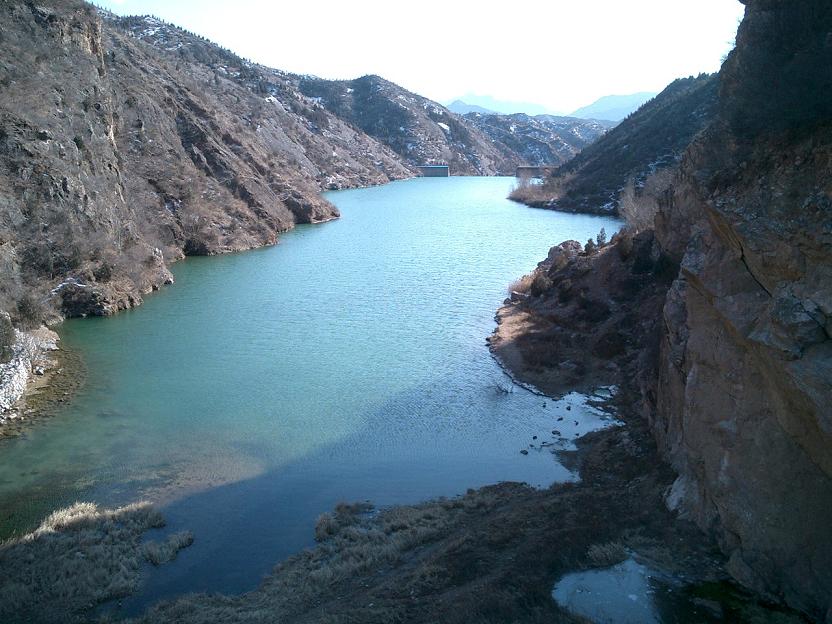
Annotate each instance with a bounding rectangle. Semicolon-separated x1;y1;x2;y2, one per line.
298;76;522;175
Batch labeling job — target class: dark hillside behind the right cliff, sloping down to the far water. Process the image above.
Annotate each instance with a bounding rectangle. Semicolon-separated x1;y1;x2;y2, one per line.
512;75;717;214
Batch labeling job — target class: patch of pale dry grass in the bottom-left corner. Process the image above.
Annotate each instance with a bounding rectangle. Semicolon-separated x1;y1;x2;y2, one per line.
0;503;188;622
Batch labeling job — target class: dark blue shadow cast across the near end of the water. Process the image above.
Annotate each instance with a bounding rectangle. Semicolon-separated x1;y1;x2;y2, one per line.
110;372;600;616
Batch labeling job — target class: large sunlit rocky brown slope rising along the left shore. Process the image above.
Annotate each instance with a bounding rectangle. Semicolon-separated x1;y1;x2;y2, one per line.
0;0;412;324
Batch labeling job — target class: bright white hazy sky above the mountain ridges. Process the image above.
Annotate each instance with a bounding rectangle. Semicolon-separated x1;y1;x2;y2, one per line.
97;0;743;112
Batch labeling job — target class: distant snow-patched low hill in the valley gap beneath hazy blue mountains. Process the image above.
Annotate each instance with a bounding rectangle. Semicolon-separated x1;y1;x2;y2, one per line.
465;112;615;166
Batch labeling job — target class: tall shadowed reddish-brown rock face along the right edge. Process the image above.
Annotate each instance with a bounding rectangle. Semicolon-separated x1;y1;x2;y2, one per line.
653;0;832;621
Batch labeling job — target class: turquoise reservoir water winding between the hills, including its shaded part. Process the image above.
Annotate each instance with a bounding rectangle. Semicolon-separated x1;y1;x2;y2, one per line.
0;178;618;600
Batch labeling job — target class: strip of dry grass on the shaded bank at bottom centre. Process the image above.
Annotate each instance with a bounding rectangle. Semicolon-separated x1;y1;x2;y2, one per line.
140;491;497;624
